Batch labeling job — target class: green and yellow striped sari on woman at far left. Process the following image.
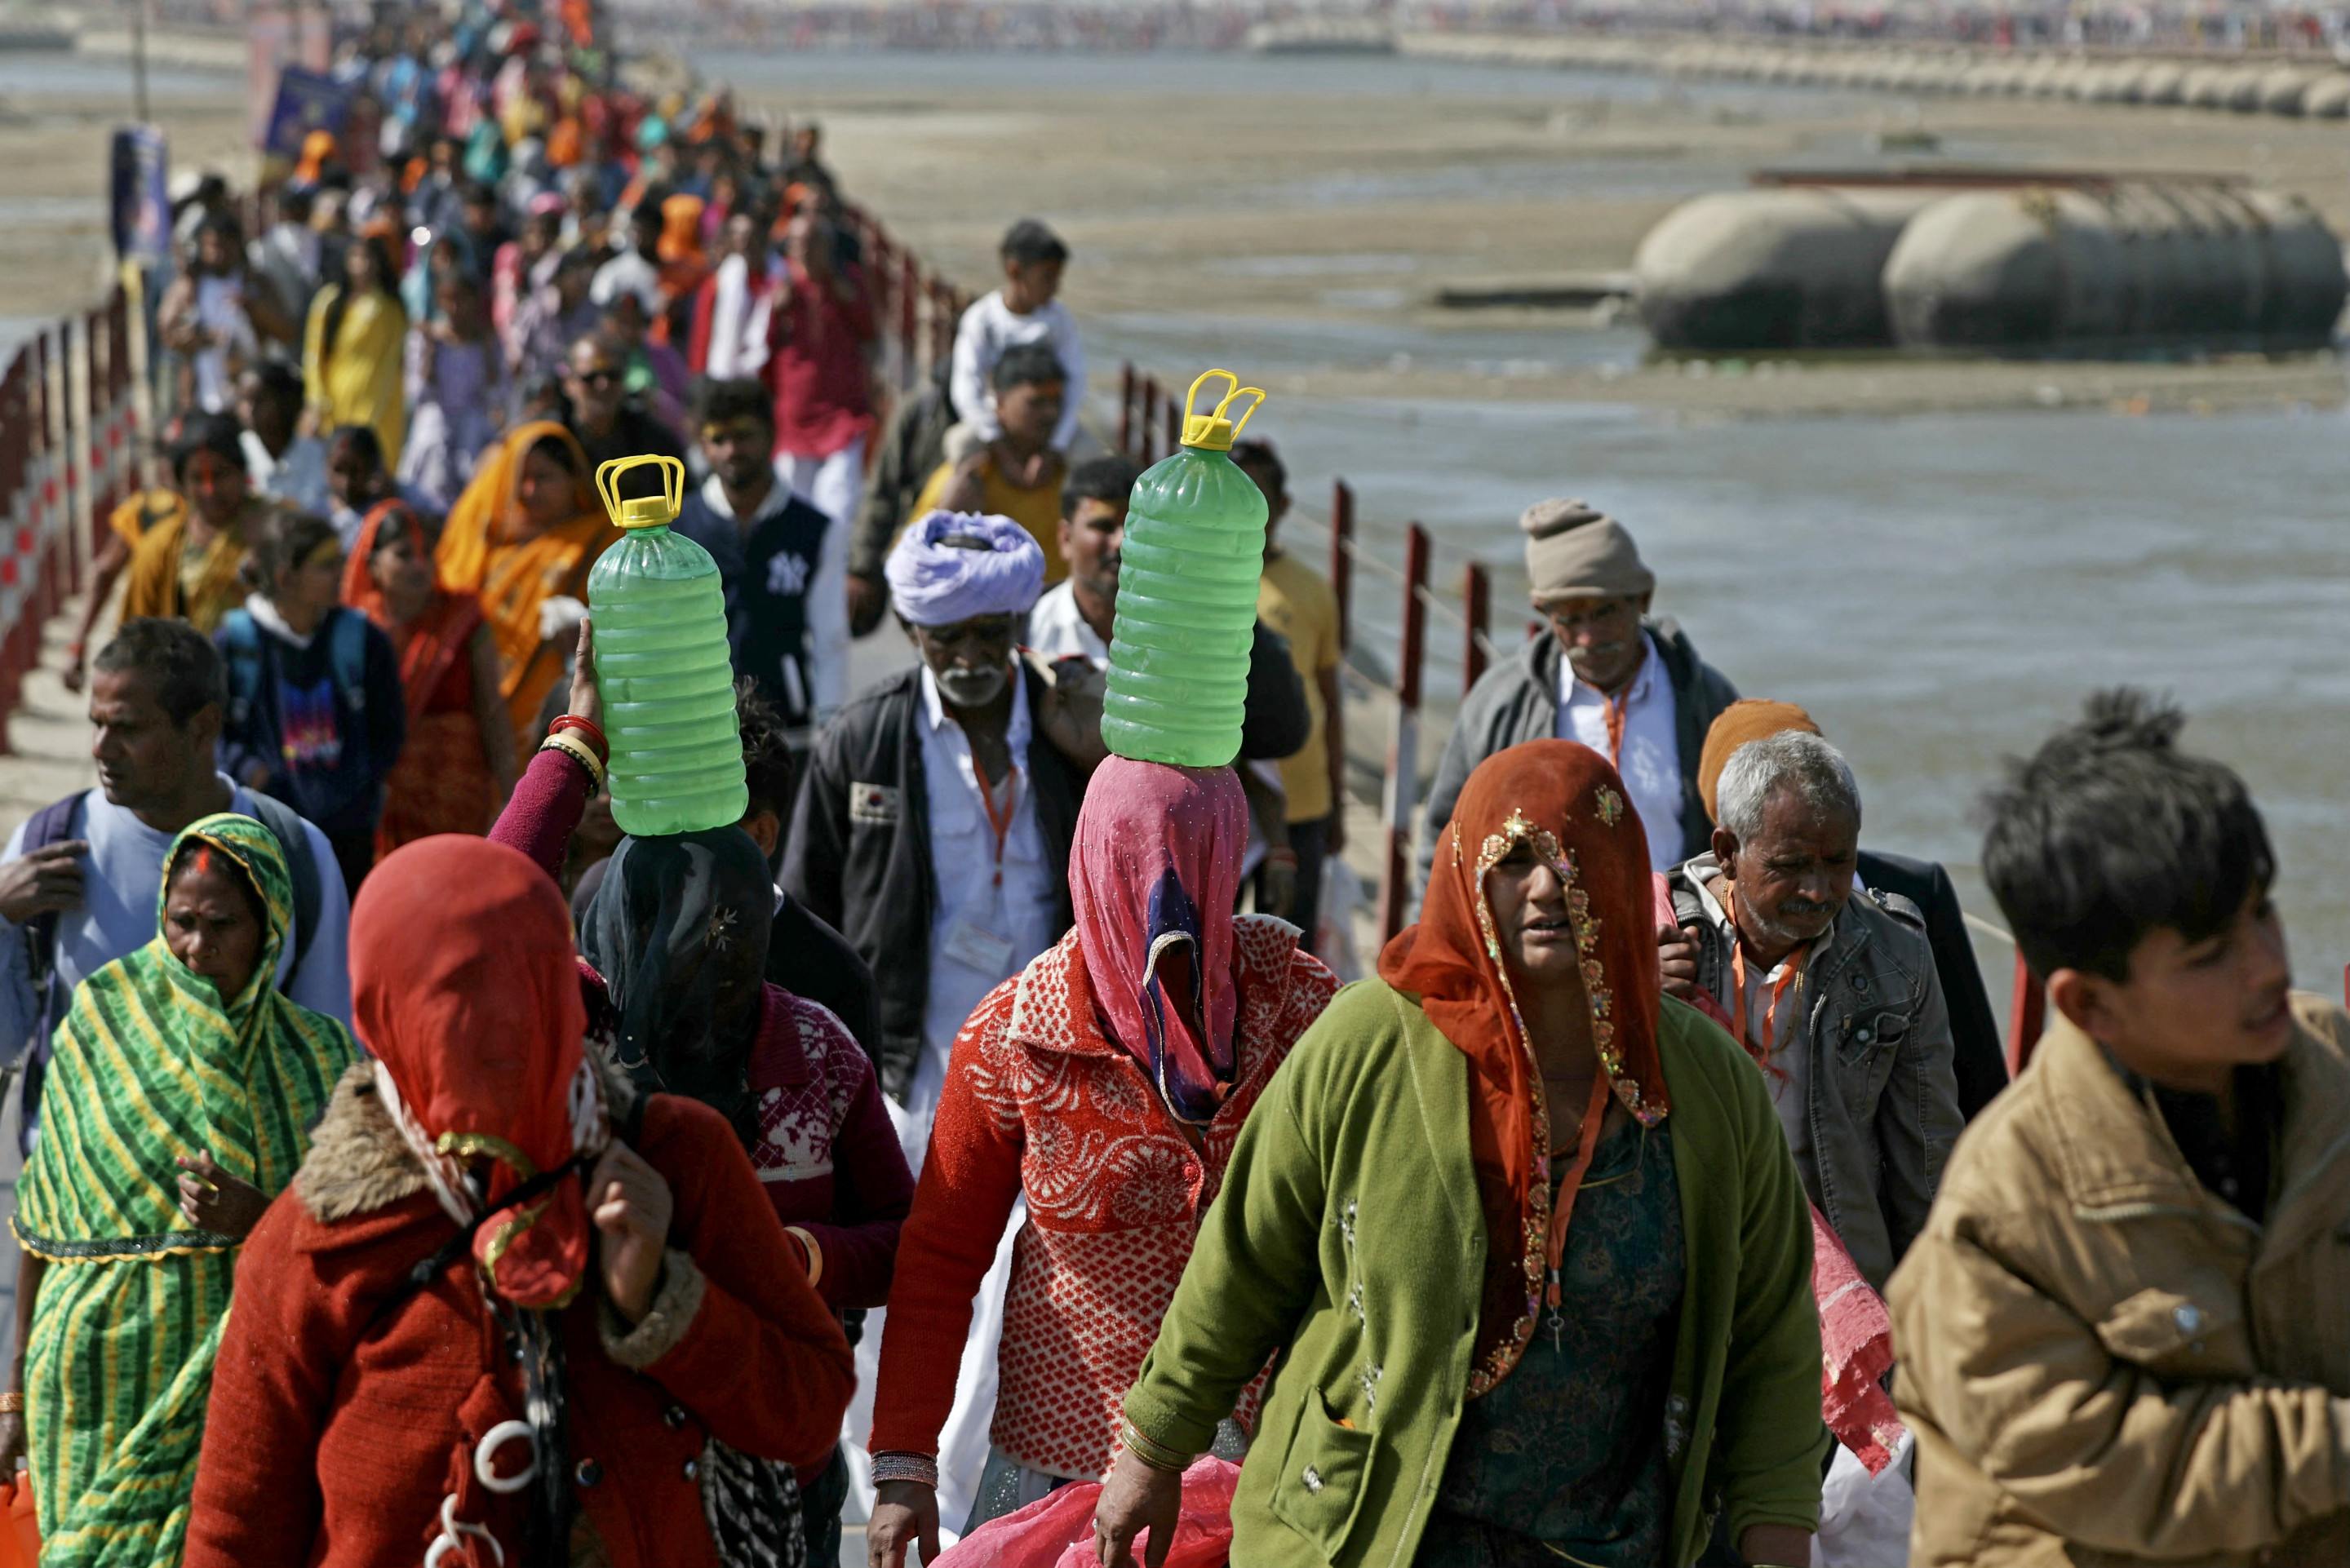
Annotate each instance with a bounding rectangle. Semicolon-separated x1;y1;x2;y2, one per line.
14;813;352;1568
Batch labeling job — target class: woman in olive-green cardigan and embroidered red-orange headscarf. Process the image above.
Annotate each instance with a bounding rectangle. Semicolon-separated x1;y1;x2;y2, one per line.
1090;741;1829;1568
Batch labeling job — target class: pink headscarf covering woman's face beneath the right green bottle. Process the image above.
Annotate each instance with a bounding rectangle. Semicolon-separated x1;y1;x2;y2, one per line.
1069;757;1248;1123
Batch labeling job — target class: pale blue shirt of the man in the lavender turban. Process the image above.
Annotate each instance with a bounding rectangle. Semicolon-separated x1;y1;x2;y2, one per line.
907;667;1060;1112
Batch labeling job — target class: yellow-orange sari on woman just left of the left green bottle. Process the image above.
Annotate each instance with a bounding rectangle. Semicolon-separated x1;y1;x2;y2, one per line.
435;421;620;757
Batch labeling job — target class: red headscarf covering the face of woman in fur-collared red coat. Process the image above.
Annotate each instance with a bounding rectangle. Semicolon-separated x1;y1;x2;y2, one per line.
350;835;609;1307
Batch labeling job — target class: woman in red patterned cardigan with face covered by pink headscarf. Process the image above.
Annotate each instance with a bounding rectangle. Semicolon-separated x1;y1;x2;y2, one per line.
865;757;1337;1568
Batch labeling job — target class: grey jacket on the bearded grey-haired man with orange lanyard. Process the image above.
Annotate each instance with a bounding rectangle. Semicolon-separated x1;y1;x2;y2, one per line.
1666;853;1965;1291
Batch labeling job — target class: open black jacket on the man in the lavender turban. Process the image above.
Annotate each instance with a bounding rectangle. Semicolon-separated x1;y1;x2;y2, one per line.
783;661;1086;1101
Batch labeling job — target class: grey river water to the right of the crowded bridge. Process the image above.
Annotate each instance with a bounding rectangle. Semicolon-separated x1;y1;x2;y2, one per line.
710;54;2350;999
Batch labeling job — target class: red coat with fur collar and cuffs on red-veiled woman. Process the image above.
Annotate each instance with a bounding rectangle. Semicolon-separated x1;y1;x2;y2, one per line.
186;1072;855;1568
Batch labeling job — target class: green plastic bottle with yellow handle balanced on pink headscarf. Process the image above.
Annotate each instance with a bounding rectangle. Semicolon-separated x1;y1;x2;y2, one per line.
1099;369;1264;768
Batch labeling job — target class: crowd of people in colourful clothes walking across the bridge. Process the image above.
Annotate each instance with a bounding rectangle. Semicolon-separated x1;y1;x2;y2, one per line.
0;2;2350;1568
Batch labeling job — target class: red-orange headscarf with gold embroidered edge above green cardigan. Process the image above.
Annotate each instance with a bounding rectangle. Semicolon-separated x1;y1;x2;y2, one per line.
1380;741;1671;1394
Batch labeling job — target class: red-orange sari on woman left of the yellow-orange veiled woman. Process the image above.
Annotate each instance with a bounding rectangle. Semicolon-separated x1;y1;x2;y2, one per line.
343;501;499;861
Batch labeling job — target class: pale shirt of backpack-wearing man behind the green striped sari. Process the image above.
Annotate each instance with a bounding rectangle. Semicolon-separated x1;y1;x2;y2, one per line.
0;773;350;1061
